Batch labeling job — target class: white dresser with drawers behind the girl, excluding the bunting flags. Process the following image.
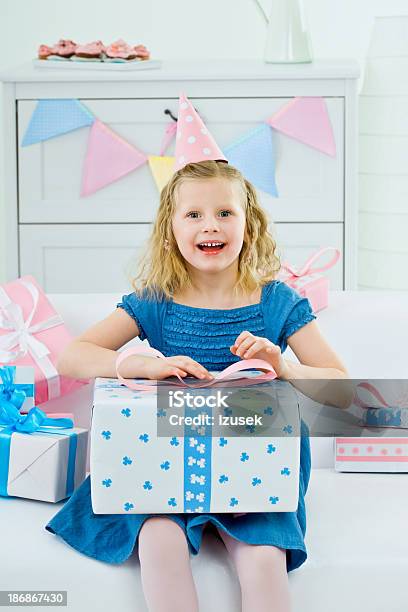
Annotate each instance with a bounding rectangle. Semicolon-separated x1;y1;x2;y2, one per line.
0;60;359;293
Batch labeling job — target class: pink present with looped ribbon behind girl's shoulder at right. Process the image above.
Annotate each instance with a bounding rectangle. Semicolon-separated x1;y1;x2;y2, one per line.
278;247;340;312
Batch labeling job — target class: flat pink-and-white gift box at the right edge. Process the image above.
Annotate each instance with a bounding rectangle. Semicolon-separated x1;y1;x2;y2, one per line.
334;437;408;472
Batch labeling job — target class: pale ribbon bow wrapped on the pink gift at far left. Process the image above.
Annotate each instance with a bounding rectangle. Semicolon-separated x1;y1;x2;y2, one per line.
0;280;63;399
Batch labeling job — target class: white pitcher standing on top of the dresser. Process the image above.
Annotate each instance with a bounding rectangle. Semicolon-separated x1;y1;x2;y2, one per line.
256;0;312;64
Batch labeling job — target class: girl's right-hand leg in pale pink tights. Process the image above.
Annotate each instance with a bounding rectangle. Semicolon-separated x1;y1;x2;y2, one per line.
218;529;291;612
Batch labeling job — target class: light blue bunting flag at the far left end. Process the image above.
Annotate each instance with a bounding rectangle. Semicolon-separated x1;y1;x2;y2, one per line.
22;99;95;147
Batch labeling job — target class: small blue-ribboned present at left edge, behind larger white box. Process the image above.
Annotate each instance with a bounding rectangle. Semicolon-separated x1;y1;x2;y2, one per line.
0;365;34;412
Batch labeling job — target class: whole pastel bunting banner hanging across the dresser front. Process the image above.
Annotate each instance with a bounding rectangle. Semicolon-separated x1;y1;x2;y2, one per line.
22;97;336;197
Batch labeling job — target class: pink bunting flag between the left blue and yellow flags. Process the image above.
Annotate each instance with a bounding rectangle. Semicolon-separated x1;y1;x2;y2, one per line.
81;119;147;196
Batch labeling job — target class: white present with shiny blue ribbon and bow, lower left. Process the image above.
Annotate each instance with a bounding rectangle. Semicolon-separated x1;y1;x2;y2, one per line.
0;401;88;502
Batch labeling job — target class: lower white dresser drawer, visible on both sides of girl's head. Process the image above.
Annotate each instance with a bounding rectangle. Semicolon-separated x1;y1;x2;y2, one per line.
20;223;343;293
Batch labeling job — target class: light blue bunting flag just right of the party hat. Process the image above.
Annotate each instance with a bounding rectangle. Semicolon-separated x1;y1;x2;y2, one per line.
224;123;278;198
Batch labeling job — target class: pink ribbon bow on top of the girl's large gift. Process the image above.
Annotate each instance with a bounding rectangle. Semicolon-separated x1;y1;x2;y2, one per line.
116;346;277;391
